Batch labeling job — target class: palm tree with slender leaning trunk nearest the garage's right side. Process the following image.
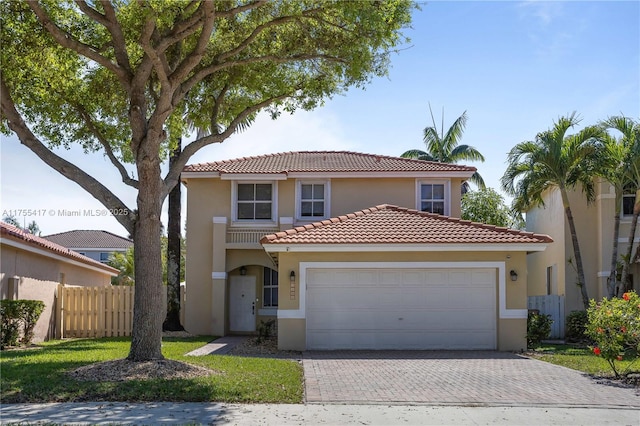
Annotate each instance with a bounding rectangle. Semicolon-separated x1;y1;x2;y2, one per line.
501;112;603;309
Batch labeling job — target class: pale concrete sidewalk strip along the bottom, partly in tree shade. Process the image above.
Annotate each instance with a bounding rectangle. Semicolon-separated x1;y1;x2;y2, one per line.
0;402;640;426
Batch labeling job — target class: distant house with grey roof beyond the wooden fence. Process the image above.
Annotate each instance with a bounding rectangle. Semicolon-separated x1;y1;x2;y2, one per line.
44;229;133;263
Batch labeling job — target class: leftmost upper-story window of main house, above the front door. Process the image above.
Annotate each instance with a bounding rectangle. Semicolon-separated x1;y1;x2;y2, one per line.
234;182;275;221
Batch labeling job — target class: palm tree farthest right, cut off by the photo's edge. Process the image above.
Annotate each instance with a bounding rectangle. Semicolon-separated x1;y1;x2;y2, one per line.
602;116;640;297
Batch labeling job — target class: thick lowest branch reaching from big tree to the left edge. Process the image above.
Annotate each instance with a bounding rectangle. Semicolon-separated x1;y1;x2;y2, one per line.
0;75;136;234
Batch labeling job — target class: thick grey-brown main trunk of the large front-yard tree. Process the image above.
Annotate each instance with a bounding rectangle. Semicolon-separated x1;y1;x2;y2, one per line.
128;153;164;361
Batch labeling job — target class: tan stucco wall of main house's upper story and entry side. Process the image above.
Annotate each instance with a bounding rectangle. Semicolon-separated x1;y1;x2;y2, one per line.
184;173;470;335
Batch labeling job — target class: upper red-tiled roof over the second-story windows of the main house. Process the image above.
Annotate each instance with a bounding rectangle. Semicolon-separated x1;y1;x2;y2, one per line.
183;151;476;174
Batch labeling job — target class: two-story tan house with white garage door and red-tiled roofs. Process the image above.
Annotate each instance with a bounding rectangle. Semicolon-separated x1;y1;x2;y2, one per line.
182;152;551;350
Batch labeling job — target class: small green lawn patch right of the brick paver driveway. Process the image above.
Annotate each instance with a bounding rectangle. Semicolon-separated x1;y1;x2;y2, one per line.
528;344;640;376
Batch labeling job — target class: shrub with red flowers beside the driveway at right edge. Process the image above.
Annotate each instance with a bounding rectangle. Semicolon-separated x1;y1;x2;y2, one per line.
586;292;640;377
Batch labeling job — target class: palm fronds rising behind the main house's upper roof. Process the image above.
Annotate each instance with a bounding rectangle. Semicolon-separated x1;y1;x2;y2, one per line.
400;104;485;193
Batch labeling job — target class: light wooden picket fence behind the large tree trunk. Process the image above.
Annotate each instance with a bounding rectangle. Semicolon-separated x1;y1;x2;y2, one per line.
56;285;184;339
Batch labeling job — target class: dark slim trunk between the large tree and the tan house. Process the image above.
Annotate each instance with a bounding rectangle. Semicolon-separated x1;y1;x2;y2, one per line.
162;140;184;331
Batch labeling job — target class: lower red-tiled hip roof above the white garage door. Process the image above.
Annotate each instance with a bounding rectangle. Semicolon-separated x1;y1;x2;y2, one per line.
260;204;553;246
